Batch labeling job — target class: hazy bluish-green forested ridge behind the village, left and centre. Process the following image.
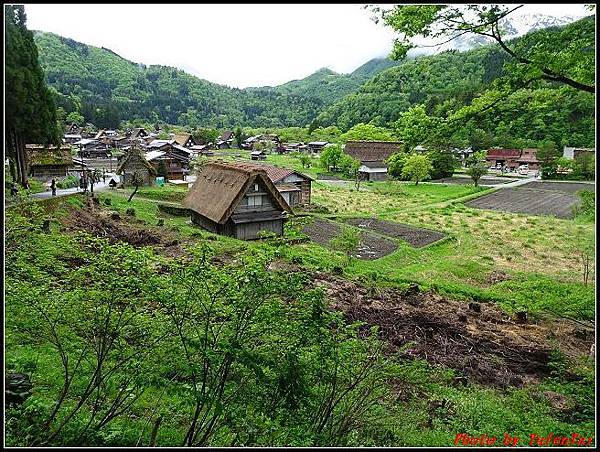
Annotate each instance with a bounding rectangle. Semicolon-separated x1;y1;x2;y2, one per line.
35;32;394;128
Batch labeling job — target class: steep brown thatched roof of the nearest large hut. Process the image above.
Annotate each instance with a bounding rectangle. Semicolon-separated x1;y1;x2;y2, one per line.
183;163;292;224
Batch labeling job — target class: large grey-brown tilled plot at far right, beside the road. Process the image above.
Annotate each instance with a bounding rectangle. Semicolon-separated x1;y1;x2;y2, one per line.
465;184;579;218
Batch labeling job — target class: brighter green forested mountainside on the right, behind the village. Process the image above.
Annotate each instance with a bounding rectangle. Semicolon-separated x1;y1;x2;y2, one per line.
317;16;595;146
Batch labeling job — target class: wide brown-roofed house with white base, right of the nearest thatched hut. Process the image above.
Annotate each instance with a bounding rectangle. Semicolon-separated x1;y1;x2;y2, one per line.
344;141;402;181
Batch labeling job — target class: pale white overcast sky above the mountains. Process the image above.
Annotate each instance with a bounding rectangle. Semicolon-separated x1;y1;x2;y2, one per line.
25;4;590;88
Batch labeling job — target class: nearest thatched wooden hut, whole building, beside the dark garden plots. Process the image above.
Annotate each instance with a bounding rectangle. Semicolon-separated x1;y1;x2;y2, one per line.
184;163;292;240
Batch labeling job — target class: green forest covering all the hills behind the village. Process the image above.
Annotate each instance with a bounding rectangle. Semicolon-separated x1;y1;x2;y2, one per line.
35;16;595;148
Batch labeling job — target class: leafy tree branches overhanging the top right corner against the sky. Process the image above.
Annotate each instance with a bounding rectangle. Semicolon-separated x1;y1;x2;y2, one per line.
375;5;595;93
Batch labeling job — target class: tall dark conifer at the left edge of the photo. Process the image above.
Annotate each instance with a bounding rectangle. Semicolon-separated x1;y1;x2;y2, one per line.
4;5;60;184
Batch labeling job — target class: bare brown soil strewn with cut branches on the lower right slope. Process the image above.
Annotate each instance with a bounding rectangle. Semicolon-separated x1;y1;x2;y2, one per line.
313;273;593;388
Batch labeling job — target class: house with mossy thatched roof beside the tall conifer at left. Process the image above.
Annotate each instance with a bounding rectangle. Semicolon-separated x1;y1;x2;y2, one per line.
25;144;73;180
